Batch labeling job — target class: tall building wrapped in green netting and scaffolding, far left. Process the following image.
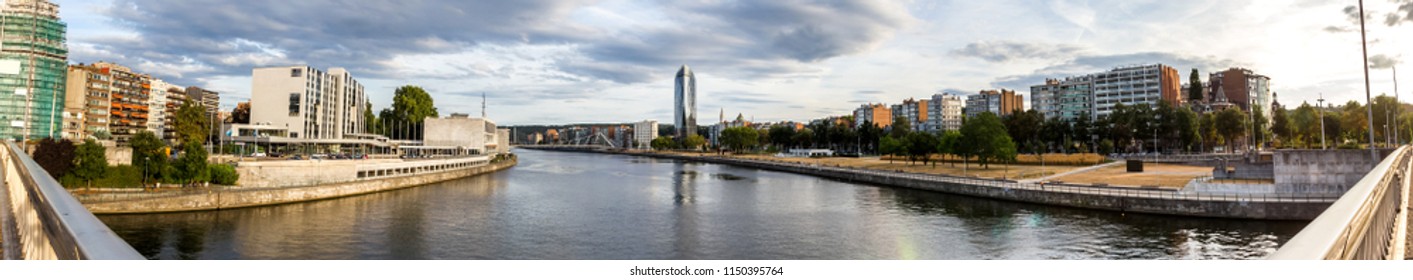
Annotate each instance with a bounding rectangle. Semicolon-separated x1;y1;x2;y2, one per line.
0;0;68;139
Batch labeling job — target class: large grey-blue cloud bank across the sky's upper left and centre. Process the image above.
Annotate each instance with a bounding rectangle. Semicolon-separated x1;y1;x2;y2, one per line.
82;0;916;83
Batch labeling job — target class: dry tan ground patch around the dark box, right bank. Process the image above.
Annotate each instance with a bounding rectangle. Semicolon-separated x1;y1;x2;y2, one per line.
1054;164;1212;188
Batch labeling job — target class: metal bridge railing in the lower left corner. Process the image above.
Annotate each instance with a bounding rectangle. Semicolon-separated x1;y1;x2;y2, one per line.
0;141;146;260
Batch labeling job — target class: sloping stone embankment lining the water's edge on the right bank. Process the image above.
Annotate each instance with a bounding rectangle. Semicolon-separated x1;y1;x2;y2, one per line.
526;147;1338;221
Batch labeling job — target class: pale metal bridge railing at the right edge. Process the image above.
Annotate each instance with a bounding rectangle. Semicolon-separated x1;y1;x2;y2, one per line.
1270;146;1413;260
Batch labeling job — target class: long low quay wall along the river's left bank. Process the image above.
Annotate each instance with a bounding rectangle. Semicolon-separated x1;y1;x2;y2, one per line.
85;158;517;214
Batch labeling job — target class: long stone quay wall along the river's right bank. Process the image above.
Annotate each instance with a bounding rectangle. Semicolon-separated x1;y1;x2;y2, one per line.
533;147;1331;221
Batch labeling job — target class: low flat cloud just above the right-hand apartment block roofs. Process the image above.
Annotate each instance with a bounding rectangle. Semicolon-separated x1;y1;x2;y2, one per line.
991;52;1242;91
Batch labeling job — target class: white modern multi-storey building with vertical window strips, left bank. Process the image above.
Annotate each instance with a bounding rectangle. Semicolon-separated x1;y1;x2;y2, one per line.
250;65;367;139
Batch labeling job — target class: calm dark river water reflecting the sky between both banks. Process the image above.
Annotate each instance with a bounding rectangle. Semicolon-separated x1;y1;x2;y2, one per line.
99;148;1306;259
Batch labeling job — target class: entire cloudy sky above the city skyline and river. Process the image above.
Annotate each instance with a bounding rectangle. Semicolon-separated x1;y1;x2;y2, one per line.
58;0;1413;124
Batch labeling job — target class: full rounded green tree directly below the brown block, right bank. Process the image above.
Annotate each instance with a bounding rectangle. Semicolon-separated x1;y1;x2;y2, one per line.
962;112;1016;168
